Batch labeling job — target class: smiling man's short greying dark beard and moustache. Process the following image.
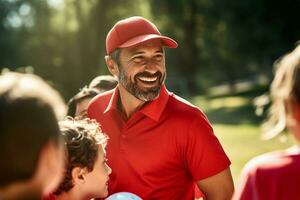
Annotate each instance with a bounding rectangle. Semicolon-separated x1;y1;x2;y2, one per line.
119;66;166;102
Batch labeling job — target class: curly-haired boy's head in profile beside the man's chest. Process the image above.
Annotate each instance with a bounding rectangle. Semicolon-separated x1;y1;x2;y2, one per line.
54;118;111;199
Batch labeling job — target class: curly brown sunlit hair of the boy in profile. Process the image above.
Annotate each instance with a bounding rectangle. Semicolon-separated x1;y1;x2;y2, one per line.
54;117;108;195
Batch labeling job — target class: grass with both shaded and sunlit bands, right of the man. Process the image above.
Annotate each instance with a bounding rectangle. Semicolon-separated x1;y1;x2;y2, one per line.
192;90;294;184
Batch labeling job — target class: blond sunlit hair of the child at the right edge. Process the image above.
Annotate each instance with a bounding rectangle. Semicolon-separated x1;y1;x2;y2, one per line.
263;45;300;138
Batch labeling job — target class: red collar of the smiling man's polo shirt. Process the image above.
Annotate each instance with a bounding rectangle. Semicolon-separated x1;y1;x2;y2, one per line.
104;85;170;121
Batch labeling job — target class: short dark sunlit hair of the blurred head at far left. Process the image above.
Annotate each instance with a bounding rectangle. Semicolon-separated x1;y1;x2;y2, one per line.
0;72;65;186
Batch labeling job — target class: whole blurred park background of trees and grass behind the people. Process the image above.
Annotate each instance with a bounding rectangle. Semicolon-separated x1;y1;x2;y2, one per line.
0;0;300;187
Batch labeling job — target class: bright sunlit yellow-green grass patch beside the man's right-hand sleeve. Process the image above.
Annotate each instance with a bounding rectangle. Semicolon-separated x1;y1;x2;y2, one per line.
213;124;293;183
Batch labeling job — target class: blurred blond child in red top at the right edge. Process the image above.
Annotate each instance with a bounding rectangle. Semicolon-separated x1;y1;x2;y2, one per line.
233;46;300;200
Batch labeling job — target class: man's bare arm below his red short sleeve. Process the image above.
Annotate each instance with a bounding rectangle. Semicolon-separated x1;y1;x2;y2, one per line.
197;167;234;200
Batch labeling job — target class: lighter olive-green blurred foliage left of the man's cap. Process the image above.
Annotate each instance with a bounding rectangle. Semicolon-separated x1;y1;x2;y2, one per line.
0;0;147;98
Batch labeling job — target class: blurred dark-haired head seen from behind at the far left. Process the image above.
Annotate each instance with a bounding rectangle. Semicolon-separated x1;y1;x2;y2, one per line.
0;72;66;198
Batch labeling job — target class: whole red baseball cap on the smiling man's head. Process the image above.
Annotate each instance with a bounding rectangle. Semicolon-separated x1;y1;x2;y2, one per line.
106;16;178;54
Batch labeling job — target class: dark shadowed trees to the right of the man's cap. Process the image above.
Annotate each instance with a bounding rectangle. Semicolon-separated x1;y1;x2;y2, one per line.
150;0;300;92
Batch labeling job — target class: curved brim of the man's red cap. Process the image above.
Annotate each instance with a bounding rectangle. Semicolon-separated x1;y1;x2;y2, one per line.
119;34;178;48
